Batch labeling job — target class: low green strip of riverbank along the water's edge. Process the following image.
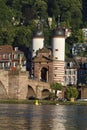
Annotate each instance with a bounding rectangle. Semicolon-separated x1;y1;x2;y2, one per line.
0;99;87;105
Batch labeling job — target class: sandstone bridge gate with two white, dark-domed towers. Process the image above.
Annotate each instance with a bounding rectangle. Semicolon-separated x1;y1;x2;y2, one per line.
30;20;66;85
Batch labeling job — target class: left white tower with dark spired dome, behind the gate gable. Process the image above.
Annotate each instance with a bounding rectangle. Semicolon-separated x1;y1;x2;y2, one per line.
32;21;44;58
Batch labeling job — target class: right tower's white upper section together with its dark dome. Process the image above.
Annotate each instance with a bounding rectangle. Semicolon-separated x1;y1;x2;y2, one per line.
52;27;65;61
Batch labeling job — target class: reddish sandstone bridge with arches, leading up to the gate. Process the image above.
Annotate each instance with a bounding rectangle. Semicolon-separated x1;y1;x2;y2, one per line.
0;71;51;99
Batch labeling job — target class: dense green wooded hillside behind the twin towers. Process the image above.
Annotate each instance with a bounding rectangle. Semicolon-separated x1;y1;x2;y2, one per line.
0;0;87;46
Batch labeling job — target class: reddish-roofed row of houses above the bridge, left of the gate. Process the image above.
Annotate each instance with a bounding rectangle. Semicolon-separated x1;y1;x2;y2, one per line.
0;45;26;70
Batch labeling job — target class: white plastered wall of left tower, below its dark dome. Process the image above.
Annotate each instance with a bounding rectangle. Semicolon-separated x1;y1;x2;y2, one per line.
32;38;44;57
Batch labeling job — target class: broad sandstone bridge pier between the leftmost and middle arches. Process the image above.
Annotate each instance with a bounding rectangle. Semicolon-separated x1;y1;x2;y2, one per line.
9;72;28;99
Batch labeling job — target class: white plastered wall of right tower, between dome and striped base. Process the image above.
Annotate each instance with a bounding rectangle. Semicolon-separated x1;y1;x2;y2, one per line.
53;37;65;61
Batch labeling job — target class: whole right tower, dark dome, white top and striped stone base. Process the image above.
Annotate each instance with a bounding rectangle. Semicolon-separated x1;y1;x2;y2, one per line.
52;17;65;85
